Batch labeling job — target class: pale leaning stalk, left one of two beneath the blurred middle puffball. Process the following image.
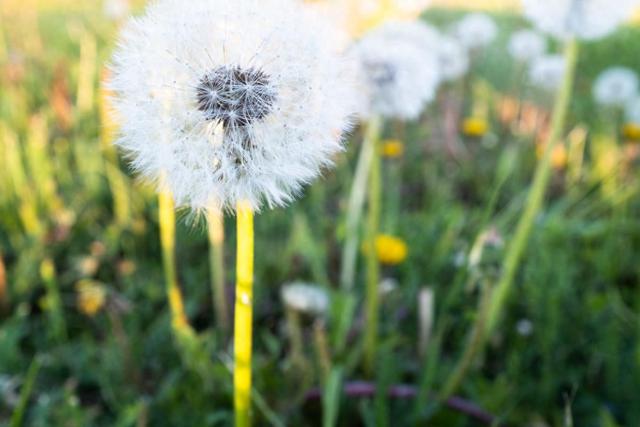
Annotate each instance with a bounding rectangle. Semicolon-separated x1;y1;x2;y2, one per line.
340;117;382;291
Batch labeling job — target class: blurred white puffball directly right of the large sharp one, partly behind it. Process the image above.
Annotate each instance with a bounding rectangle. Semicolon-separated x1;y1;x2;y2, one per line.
351;25;440;120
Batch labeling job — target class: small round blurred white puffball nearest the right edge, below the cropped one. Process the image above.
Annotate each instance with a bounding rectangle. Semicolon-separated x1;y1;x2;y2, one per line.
593;67;639;108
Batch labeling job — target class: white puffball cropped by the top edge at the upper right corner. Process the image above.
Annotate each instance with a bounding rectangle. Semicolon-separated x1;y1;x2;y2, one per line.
523;0;638;40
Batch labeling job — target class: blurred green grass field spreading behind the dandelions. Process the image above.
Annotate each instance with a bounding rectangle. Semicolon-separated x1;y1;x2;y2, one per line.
0;2;640;427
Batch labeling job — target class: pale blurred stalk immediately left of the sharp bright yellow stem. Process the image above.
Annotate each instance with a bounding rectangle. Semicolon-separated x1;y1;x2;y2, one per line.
207;208;229;337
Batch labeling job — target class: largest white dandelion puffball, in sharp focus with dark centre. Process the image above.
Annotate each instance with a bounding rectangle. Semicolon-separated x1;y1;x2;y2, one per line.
110;0;356;211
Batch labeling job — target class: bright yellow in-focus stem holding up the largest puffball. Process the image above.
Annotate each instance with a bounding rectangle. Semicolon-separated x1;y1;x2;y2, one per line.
233;202;253;427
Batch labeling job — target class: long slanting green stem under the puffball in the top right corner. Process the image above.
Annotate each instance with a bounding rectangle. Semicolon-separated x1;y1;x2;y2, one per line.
486;39;578;334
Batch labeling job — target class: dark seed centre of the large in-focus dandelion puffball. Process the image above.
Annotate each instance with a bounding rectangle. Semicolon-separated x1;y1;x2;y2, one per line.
196;65;276;127
